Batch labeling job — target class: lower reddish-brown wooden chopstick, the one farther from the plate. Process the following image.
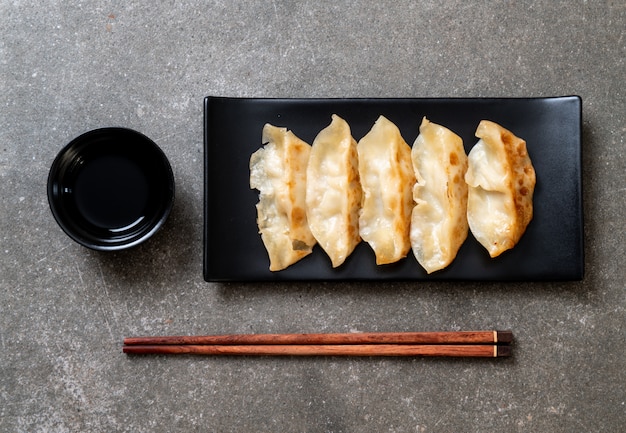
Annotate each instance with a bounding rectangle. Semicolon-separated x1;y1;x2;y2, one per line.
123;344;511;358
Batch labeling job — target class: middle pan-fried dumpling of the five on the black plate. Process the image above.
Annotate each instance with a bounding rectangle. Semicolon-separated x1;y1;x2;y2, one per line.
357;116;415;265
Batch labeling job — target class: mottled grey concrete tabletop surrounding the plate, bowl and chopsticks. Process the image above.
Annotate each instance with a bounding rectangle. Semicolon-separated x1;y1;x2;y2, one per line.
0;0;626;432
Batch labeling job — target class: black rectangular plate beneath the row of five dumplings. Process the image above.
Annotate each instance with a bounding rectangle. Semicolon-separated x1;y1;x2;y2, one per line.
204;96;584;281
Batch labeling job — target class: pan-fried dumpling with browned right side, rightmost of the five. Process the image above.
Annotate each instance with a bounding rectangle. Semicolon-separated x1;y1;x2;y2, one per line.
465;120;536;257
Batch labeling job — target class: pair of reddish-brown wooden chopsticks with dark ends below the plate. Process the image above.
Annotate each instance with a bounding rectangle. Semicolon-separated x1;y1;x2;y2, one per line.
122;331;513;358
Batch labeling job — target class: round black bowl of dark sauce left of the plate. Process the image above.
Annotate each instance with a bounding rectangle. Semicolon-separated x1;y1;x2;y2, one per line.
48;128;174;251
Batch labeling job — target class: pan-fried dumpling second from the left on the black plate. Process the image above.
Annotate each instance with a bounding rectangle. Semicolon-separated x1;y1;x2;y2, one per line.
306;114;361;267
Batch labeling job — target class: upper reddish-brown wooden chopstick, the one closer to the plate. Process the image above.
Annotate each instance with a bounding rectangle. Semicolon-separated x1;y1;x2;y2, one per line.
124;331;513;346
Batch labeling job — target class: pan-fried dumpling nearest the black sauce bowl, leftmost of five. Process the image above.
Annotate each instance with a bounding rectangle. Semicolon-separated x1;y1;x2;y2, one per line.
250;124;315;271
